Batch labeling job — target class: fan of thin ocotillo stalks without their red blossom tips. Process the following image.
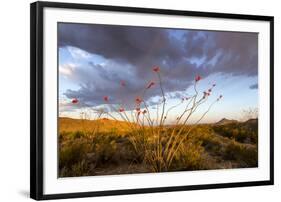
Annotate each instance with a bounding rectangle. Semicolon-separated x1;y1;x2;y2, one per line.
84;66;219;172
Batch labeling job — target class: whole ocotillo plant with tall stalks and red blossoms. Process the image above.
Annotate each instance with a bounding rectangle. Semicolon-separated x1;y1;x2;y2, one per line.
71;66;222;172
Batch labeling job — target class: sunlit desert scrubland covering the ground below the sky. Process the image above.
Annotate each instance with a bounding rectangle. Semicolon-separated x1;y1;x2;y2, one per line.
59;118;258;177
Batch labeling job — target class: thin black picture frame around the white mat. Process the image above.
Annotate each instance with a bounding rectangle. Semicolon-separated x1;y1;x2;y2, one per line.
30;2;274;200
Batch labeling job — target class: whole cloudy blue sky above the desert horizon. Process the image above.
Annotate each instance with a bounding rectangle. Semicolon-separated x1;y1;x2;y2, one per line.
58;23;258;122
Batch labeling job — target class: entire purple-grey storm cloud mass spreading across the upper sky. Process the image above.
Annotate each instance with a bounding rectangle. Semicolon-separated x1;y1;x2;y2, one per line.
58;24;258;108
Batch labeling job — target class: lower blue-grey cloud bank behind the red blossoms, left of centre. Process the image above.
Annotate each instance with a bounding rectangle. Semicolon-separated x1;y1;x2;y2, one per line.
64;60;190;109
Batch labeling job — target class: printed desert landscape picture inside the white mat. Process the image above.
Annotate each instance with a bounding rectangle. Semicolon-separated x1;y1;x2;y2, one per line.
58;23;259;177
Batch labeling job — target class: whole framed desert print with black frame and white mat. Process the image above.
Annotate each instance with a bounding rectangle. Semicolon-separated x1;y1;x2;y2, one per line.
30;2;274;200
